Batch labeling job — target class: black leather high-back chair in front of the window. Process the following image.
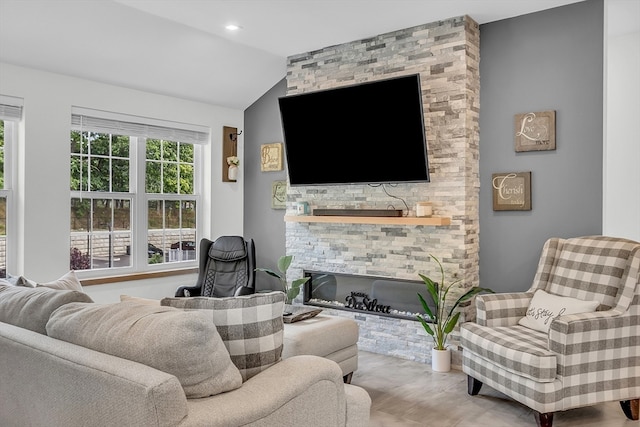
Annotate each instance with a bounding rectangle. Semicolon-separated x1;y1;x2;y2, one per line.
176;236;256;297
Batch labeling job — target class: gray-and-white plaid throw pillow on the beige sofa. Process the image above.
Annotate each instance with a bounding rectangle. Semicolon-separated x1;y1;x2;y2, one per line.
160;291;285;381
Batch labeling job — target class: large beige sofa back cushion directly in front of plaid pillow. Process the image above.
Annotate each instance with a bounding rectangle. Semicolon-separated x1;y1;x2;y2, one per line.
47;302;242;398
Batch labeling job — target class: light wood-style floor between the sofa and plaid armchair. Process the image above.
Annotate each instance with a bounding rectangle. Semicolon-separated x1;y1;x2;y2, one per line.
351;351;640;427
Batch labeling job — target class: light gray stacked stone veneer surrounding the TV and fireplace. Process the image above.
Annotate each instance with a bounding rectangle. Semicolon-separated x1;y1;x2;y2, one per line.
286;16;480;364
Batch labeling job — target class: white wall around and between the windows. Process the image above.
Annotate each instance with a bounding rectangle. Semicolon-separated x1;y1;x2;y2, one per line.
0;63;244;302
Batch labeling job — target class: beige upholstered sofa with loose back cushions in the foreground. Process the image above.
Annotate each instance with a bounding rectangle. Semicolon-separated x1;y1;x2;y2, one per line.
0;285;371;427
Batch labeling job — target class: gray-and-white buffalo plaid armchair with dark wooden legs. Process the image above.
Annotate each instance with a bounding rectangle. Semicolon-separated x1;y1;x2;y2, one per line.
460;236;640;427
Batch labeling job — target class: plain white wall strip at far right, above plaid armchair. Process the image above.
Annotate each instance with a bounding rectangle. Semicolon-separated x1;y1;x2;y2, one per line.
602;4;640;241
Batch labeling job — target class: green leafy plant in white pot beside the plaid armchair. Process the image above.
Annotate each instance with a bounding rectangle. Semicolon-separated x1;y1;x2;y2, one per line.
416;254;493;372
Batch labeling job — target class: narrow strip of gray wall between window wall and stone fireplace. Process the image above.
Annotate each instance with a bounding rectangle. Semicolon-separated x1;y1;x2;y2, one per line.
242;78;287;290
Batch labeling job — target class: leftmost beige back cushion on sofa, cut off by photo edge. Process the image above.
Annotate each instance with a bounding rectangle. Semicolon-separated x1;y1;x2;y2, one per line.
0;285;93;334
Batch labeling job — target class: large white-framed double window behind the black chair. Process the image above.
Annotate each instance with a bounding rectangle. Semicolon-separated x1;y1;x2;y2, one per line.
70;110;208;271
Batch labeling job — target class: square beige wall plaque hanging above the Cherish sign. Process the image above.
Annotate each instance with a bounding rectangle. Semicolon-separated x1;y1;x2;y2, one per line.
515;110;556;152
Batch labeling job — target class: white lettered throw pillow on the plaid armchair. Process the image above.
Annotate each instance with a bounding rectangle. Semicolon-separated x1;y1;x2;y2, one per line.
518;289;600;332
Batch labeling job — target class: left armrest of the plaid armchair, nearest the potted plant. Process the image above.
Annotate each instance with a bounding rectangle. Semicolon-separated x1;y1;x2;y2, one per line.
476;292;533;327
